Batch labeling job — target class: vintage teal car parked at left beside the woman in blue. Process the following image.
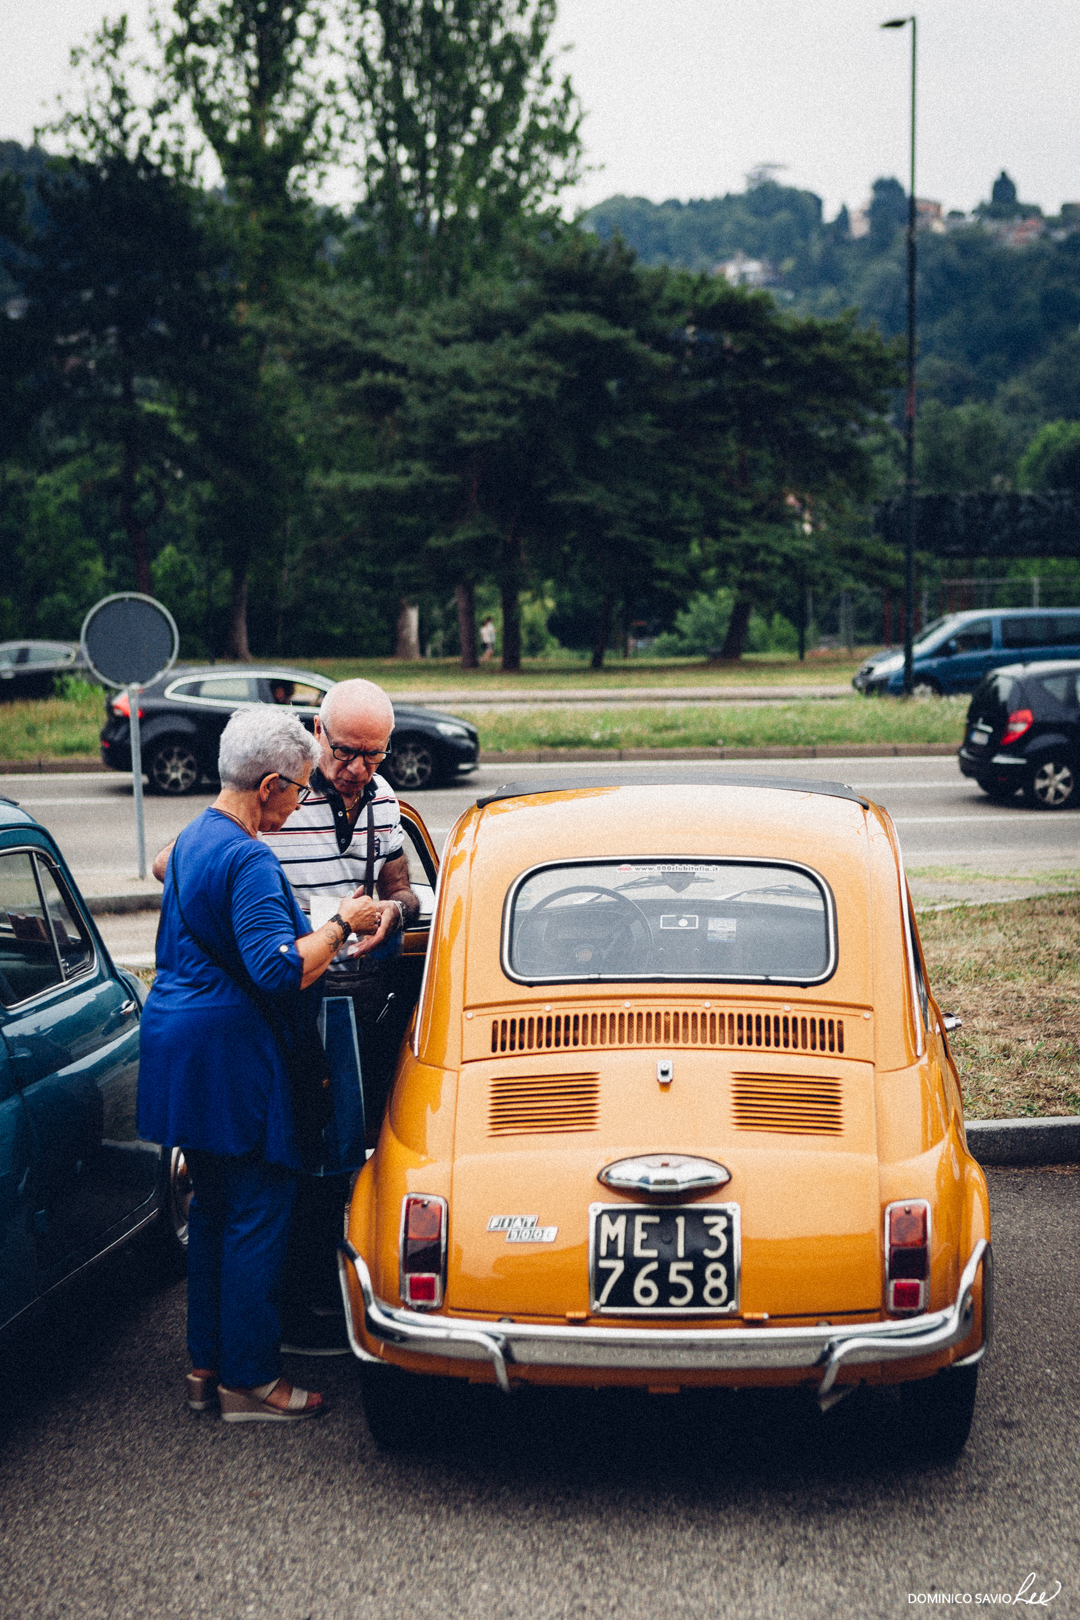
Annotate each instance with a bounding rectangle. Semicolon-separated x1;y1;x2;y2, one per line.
0;799;186;1332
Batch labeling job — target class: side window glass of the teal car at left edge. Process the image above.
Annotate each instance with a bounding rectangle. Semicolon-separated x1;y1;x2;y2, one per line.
0;851;94;1006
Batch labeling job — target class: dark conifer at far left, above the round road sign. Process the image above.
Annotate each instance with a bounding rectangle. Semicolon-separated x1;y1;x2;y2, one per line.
18;146;230;593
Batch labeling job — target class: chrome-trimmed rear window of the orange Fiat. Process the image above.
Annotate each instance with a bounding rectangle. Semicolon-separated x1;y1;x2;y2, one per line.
504;859;836;985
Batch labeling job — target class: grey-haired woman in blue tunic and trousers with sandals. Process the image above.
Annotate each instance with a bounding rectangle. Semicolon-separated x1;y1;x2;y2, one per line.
139;705;377;1422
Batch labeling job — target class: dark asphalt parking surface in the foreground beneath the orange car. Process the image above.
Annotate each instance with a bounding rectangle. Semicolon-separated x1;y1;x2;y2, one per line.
0;1170;1080;1620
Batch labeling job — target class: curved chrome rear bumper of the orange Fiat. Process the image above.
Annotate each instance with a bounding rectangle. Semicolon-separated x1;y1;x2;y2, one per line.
338;1238;991;1401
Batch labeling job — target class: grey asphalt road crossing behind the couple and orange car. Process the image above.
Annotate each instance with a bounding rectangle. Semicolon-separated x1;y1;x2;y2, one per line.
0;757;1080;962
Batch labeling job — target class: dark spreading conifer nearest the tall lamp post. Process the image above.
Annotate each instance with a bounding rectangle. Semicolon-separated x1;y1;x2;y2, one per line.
669;277;899;659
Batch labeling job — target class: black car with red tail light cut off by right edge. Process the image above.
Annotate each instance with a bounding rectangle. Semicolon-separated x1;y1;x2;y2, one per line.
960;659;1080;810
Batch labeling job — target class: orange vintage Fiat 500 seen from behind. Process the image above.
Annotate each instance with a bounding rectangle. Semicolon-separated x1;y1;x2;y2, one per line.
340;778;991;1458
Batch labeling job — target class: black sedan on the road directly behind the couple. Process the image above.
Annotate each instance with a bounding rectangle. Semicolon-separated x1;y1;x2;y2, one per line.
100;664;479;794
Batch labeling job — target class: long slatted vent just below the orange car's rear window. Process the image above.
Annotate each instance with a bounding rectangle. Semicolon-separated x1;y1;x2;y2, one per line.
491;1008;844;1053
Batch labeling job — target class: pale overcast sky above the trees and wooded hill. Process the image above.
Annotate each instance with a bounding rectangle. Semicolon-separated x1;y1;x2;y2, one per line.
0;0;1080;215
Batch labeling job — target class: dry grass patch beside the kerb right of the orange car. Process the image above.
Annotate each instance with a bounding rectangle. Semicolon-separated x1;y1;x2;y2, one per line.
918;894;1080;1119
